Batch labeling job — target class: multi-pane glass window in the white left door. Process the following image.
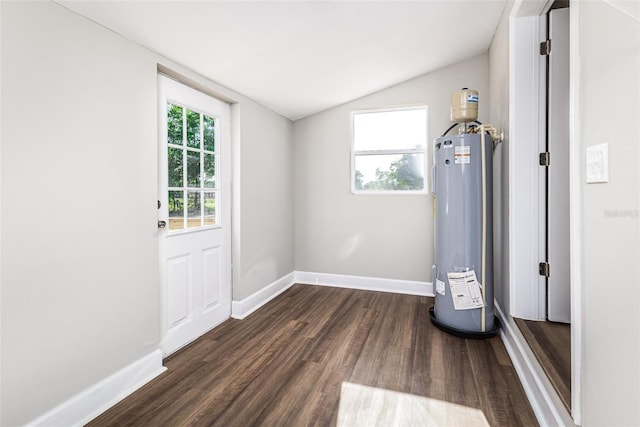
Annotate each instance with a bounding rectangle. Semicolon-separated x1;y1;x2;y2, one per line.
167;102;219;232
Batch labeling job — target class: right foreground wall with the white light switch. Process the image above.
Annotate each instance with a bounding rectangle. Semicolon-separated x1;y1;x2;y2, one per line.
577;1;640;426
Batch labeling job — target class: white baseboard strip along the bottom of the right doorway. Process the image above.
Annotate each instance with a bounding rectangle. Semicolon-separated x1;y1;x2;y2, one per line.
495;301;575;426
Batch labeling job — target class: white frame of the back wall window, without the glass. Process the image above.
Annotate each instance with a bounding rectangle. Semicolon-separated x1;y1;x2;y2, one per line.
349;104;429;195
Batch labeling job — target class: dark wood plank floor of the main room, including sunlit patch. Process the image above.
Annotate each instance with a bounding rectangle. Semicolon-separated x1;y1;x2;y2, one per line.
89;285;538;427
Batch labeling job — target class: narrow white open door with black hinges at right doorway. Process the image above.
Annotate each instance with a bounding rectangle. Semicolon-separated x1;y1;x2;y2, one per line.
547;8;571;323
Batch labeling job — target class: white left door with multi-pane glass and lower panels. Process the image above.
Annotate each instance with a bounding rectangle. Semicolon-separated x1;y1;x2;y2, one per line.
158;75;231;355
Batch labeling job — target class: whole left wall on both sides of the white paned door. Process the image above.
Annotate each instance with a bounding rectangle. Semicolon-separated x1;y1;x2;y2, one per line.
0;2;293;426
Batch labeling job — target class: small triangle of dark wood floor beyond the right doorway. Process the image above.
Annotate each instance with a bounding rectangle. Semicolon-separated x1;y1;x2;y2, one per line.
515;319;571;413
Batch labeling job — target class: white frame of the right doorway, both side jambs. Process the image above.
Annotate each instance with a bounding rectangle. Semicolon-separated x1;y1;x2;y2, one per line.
508;0;582;425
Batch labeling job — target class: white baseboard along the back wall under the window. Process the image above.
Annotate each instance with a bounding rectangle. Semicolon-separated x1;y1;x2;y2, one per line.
295;271;434;297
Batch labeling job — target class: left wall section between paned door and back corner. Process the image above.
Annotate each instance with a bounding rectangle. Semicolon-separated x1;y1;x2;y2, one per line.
233;102;294;301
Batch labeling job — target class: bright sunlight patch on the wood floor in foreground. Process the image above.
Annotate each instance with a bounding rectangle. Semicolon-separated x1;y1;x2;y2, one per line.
338;382;489;427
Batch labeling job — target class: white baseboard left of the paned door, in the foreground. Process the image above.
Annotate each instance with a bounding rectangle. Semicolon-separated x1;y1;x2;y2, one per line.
27;350;167;427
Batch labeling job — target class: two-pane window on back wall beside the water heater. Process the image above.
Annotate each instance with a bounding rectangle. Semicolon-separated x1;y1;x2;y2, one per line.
351;106;427;194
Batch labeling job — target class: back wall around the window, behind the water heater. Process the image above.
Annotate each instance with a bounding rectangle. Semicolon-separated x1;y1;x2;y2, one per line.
294;55;489;282
